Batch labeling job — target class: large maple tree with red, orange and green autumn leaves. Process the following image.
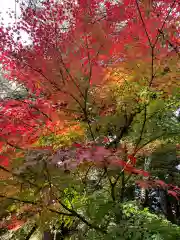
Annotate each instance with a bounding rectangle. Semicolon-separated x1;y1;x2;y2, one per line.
0;0;180;239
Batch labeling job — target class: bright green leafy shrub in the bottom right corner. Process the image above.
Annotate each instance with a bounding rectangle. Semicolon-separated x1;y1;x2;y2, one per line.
105;202;180;240
